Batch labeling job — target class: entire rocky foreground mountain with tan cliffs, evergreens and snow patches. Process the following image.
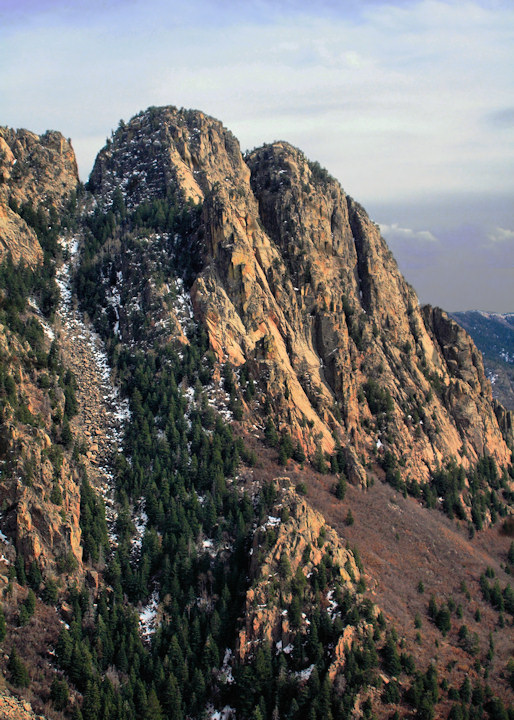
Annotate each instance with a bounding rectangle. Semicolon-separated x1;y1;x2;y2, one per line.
0;107;514;720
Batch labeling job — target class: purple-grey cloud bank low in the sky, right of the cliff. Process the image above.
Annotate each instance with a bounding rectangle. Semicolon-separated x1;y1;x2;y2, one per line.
375;200;514;312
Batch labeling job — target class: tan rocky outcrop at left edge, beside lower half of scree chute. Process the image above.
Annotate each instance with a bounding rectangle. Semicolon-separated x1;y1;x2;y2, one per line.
0;326;82;583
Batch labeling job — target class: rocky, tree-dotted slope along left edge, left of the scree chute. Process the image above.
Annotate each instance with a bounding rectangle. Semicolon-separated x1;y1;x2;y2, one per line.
0;129;112;718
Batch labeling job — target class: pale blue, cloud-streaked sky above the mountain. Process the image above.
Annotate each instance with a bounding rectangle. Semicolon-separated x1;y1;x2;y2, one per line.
0;0;514;312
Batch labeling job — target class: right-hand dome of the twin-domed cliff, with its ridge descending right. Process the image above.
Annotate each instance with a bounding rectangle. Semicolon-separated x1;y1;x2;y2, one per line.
248;143;510;480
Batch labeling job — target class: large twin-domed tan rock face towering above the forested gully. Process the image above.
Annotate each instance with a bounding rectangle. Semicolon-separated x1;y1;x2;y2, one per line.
90;107;513;490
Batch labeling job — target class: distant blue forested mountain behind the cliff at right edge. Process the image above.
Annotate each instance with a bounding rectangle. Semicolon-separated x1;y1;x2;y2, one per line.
452;310;514;410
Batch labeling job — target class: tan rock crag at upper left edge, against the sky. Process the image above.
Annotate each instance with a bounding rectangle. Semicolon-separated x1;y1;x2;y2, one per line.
0;127;78;267
